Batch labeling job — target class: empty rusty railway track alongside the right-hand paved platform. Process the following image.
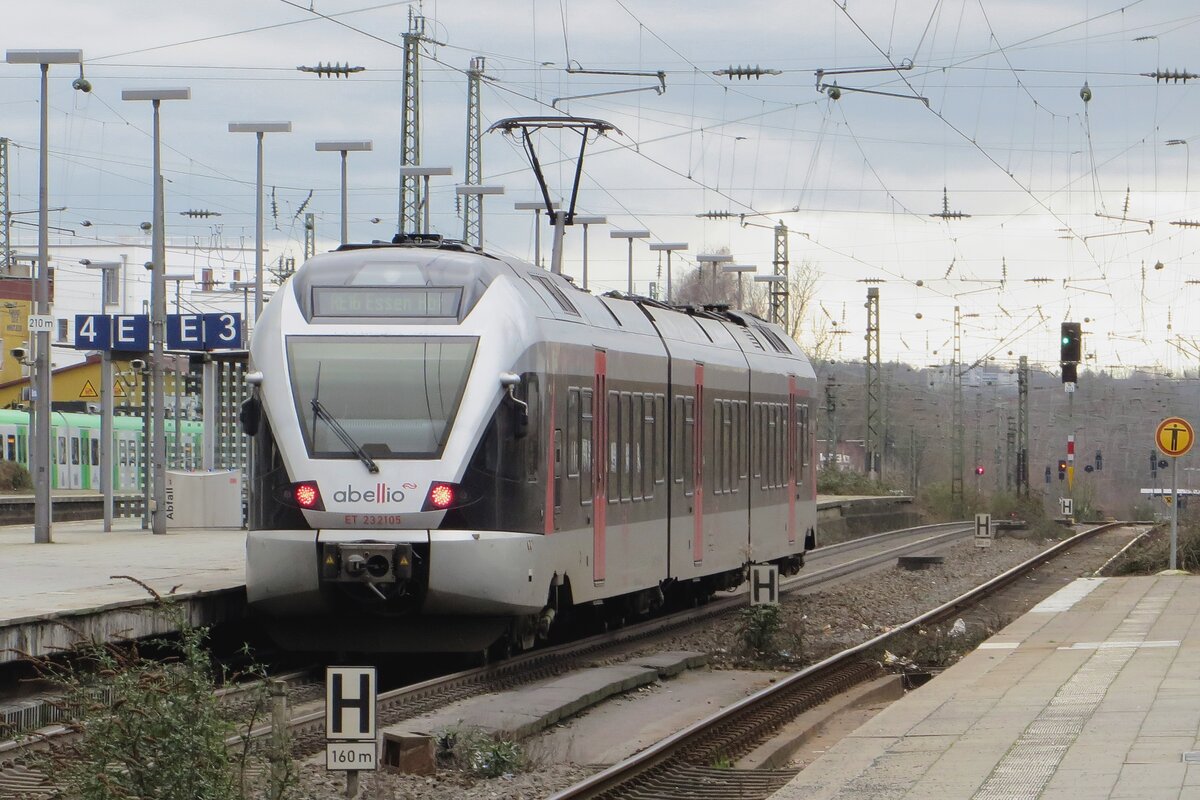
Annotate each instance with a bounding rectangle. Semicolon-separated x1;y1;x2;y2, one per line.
550;523;1123;800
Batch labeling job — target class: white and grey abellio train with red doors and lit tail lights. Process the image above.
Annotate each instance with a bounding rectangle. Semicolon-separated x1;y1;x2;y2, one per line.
242;237;816;652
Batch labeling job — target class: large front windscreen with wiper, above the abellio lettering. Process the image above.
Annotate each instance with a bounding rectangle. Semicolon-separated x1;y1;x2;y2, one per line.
287;336;479;458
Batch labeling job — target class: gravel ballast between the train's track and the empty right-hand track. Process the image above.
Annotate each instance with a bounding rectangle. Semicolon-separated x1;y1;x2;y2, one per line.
274;525;1094;800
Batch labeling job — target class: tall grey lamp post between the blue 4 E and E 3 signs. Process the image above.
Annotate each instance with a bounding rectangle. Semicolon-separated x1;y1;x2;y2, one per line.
121;89;192;534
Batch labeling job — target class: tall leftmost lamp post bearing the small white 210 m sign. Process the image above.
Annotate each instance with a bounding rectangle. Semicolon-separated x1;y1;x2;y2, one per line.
5;50;83;545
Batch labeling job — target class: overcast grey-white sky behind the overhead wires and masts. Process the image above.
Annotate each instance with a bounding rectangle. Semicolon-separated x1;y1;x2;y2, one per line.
0;0;1200;374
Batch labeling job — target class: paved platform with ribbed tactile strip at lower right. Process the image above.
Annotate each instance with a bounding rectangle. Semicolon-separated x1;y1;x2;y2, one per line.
772;575;1200;800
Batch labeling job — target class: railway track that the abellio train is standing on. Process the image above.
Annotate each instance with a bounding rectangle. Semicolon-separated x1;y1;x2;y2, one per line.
0;523;973;800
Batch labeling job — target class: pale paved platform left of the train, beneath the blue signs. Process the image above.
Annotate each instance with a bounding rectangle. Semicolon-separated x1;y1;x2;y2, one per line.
0;519;246;663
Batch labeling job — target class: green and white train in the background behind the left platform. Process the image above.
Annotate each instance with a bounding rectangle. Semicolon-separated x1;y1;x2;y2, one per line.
0;409;204;492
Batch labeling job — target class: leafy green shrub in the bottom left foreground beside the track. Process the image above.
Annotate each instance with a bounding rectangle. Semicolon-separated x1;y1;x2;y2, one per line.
29;582;292;800
